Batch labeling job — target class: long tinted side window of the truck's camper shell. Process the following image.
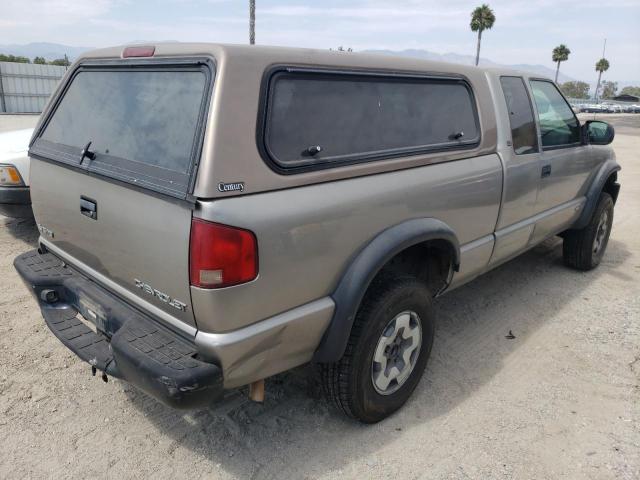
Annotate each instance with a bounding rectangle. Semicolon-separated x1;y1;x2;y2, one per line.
265;72;480;168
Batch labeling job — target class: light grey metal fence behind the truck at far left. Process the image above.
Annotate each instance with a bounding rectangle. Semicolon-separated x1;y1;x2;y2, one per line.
0;62;67;113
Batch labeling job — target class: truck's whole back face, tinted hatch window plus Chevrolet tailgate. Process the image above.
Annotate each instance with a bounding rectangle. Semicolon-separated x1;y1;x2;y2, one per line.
30;60;213;326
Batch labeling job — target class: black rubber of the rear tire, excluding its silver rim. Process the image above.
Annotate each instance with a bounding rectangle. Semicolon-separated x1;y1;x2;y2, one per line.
319;276;435;423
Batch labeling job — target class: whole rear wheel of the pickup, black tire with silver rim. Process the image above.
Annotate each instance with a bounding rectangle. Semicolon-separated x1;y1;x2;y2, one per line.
320;276;434;423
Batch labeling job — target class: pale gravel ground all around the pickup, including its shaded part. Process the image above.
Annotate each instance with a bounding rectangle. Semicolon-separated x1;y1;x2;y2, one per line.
0;115;640;479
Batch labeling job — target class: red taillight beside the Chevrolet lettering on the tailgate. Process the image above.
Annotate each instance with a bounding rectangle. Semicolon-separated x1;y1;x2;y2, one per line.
189;218;258;288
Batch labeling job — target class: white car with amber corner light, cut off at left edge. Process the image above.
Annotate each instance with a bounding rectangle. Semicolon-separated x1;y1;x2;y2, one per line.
0;128;33;218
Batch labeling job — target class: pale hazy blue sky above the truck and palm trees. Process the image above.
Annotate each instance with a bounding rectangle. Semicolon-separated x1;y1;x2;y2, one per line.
0;0;640;82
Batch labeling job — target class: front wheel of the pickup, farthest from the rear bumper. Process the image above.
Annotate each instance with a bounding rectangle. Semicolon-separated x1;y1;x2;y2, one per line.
562;192;613;271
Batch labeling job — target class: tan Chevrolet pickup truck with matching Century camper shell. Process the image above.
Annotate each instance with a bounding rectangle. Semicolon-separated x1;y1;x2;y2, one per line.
14;43;620;423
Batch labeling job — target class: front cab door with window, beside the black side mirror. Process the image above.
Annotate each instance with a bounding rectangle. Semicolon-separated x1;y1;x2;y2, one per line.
530;79;594;243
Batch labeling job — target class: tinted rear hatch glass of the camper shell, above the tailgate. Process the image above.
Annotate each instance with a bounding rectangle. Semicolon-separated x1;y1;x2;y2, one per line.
34;67;208;197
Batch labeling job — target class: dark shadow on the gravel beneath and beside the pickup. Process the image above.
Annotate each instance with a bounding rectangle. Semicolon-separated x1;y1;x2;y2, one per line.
123;238;630;478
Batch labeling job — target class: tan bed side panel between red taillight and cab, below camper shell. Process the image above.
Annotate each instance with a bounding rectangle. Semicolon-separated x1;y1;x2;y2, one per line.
191;155;502;332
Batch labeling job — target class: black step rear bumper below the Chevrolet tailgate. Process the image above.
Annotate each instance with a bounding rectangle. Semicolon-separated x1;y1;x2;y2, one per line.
14;250;223;408
